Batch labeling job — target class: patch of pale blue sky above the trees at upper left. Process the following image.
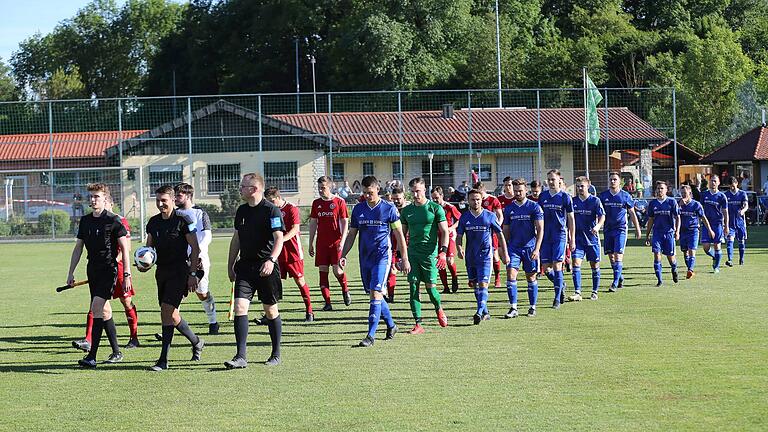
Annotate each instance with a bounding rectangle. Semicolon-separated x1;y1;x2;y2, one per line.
0;0;124;65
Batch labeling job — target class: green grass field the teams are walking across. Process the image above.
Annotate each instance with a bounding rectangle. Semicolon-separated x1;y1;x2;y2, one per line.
0;228;768;431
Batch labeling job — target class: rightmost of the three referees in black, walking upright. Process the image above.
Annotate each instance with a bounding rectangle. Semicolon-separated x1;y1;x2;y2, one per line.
224;173;283;369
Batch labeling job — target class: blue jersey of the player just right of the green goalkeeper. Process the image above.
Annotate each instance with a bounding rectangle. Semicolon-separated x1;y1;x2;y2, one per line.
456;209;501;266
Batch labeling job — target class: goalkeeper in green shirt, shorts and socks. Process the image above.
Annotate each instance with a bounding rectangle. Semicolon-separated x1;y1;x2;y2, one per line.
400;177;448;334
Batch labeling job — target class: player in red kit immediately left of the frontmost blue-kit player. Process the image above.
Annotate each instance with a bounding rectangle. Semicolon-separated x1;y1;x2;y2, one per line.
309;176;352;311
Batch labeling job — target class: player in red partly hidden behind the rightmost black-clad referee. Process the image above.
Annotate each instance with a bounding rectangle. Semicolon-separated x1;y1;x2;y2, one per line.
264;187;315;322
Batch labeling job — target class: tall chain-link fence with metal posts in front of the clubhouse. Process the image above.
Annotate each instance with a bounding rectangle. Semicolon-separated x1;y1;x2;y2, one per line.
0;88;680;240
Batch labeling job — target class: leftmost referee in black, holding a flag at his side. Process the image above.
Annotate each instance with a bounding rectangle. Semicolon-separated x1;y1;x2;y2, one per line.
67;183;131;368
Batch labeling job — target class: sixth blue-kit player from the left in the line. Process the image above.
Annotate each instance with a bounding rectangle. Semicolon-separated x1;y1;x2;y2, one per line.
599;172;641;292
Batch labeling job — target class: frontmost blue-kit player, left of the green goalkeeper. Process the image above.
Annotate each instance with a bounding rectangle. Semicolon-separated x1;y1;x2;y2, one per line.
339;176;410;347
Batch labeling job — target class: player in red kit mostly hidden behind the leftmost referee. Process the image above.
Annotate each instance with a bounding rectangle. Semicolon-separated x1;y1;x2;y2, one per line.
72;196;139;352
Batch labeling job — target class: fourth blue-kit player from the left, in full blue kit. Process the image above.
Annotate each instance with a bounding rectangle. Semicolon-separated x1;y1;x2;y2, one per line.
539;170;576;309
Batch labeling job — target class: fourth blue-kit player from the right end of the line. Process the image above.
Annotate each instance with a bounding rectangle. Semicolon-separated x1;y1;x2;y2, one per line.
645;180;680;287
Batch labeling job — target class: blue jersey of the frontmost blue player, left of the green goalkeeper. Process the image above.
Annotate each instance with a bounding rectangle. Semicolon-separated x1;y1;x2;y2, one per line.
350;200;400;264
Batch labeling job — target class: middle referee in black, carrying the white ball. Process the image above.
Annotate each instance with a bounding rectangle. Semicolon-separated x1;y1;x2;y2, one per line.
139;185;205;372
